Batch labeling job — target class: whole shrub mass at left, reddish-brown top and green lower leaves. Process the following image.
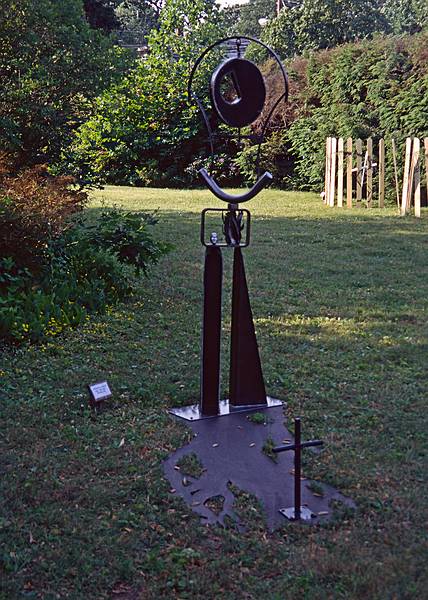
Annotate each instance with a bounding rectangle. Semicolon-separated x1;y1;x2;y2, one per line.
0;169;169;343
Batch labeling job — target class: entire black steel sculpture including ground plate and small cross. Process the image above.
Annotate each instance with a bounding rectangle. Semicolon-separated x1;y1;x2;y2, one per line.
163;37;355;529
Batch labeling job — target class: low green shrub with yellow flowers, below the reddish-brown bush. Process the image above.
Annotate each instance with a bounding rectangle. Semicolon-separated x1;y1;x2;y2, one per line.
0;209;170;342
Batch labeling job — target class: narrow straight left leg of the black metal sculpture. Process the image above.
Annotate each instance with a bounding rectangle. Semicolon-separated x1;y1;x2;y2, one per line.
200;246;223;416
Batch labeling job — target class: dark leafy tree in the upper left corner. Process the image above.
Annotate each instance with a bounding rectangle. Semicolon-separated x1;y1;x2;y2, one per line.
0;0;129;166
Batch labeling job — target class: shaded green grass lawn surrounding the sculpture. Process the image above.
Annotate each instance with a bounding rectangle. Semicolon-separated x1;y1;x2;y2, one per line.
0;187;428;600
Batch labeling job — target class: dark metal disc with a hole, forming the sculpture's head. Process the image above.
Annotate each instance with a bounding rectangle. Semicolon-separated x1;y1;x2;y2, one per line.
210;58;266;127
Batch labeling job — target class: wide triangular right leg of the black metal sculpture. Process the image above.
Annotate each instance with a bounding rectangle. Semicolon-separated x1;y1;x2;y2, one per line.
229;248;267;407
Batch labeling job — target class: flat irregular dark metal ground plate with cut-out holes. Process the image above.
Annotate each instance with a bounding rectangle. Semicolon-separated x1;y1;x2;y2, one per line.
163;405;355;530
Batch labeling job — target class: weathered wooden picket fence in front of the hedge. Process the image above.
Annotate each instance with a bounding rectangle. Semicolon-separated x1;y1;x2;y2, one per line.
323;137;428;217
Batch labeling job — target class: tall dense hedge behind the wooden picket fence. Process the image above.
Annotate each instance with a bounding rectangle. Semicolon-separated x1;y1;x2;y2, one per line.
238;32;428;199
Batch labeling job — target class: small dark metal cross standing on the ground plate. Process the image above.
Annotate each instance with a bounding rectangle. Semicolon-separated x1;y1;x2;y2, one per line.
273;417;324;521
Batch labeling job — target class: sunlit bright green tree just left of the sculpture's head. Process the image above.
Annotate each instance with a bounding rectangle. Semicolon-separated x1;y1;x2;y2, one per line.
66;0;224;185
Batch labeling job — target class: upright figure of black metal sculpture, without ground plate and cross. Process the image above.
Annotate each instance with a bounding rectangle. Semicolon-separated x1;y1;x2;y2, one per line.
171;37;288;420
